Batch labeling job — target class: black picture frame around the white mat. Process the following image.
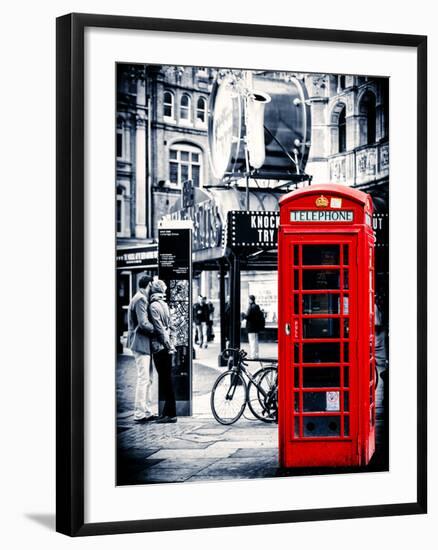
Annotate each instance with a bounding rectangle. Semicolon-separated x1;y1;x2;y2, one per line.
56;13;427;536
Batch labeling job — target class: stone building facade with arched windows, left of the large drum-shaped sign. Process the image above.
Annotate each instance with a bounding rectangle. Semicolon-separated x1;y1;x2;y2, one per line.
116;64;215;245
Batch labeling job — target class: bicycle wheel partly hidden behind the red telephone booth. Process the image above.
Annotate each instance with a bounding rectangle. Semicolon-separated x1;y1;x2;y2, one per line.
248;367;277;422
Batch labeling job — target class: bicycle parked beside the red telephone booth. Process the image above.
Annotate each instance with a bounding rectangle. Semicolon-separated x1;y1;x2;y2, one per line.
210;348;278;425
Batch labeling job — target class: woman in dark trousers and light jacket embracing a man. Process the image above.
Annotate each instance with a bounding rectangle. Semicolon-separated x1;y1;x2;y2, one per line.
149;280;177;424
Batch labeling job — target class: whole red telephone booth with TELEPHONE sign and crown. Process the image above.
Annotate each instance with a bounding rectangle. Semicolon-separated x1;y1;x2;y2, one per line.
278;184;376;468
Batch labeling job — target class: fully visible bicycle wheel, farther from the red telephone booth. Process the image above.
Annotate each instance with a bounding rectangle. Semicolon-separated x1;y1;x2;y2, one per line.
210;371;247;425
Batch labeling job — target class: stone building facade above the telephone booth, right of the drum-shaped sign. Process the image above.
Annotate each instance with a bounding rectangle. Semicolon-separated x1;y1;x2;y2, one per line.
305;75;389;192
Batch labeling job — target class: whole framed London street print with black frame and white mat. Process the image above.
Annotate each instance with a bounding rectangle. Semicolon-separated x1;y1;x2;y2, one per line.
57;14;427;536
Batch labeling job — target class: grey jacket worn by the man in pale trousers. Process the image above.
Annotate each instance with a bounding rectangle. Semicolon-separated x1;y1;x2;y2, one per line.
128;291;154;355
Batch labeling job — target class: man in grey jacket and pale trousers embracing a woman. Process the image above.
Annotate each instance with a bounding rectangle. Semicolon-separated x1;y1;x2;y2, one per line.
128;275;157;422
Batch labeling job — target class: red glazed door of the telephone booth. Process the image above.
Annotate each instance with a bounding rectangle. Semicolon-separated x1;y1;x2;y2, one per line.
282;234;358;466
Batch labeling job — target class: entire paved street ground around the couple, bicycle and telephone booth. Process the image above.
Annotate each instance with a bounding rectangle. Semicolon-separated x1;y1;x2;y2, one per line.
117;343;384;485
